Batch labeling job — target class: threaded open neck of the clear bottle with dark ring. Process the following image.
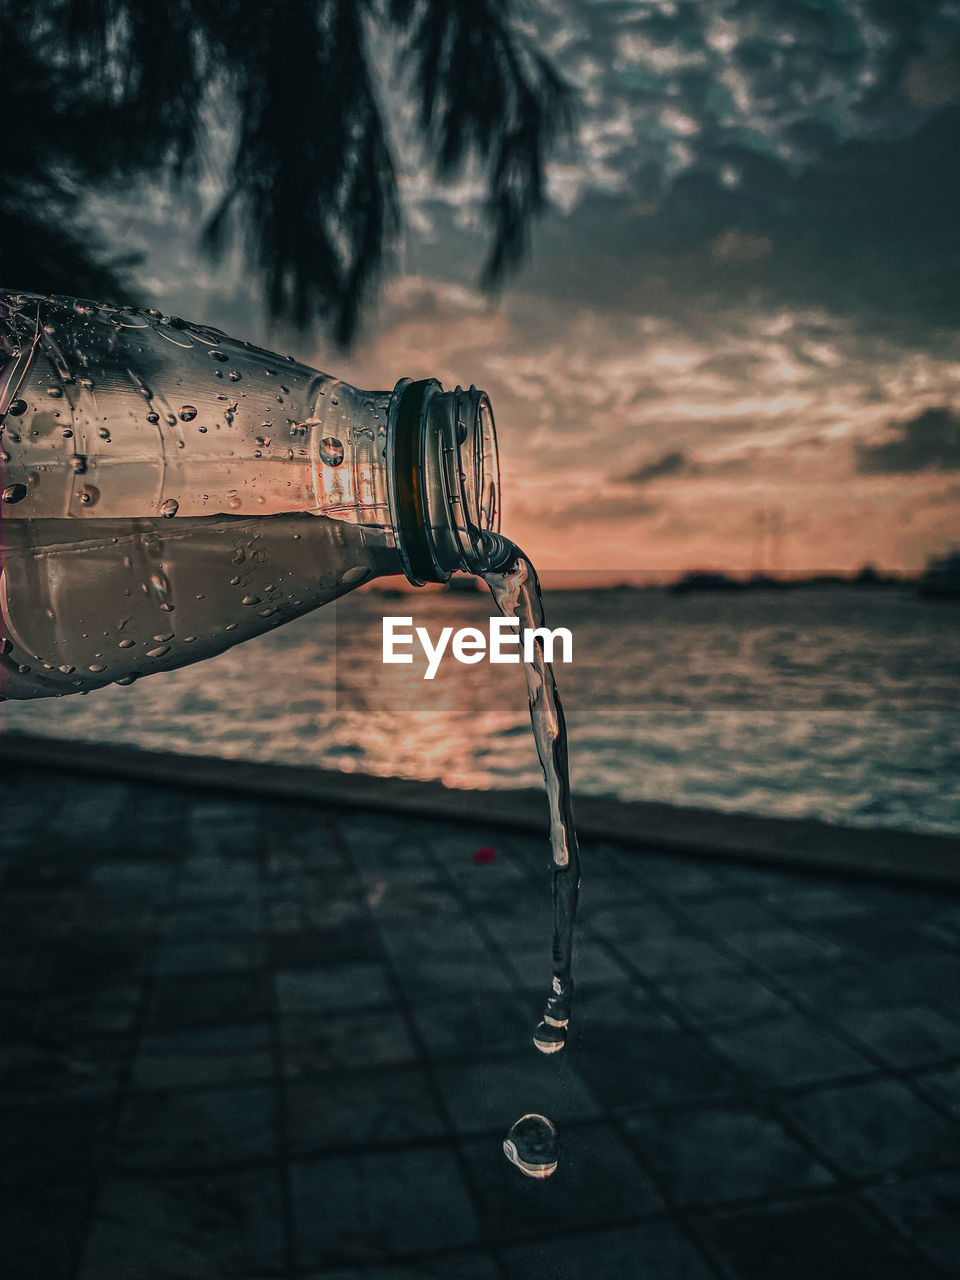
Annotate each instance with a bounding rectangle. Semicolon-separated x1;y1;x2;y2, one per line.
387;379;507;586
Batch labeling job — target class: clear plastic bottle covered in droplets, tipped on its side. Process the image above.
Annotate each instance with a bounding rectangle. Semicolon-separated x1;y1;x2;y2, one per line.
0;293;507;698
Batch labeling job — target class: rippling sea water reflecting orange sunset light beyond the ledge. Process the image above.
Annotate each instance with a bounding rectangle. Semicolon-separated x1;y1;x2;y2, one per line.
3;588;960;833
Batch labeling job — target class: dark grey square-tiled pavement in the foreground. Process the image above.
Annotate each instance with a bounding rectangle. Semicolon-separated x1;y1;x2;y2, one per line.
0;763;960;1280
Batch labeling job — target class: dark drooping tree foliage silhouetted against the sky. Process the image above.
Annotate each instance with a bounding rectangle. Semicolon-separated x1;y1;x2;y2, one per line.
0;0;571;343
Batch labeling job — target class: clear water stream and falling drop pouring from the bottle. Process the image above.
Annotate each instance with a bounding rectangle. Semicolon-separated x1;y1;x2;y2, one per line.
484;544;580;1178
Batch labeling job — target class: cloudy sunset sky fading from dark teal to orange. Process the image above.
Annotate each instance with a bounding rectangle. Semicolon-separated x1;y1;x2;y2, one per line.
91;0;960;579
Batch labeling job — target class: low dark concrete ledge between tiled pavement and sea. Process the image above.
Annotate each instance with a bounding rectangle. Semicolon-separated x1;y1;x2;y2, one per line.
1;733;960;891
